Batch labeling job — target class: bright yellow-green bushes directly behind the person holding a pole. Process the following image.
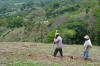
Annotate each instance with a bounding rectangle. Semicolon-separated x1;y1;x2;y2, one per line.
46;28;76;43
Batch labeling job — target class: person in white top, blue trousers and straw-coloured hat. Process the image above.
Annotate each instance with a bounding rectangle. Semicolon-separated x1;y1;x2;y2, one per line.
83;35;92;60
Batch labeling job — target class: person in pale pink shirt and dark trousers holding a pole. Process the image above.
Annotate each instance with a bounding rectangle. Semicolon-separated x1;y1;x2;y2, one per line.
53;33;63;57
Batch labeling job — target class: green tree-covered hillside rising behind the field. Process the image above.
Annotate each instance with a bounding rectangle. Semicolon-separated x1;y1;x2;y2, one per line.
0;0;100;45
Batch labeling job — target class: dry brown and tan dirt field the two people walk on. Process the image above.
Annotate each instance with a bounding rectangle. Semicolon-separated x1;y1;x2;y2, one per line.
0;42;100;66
